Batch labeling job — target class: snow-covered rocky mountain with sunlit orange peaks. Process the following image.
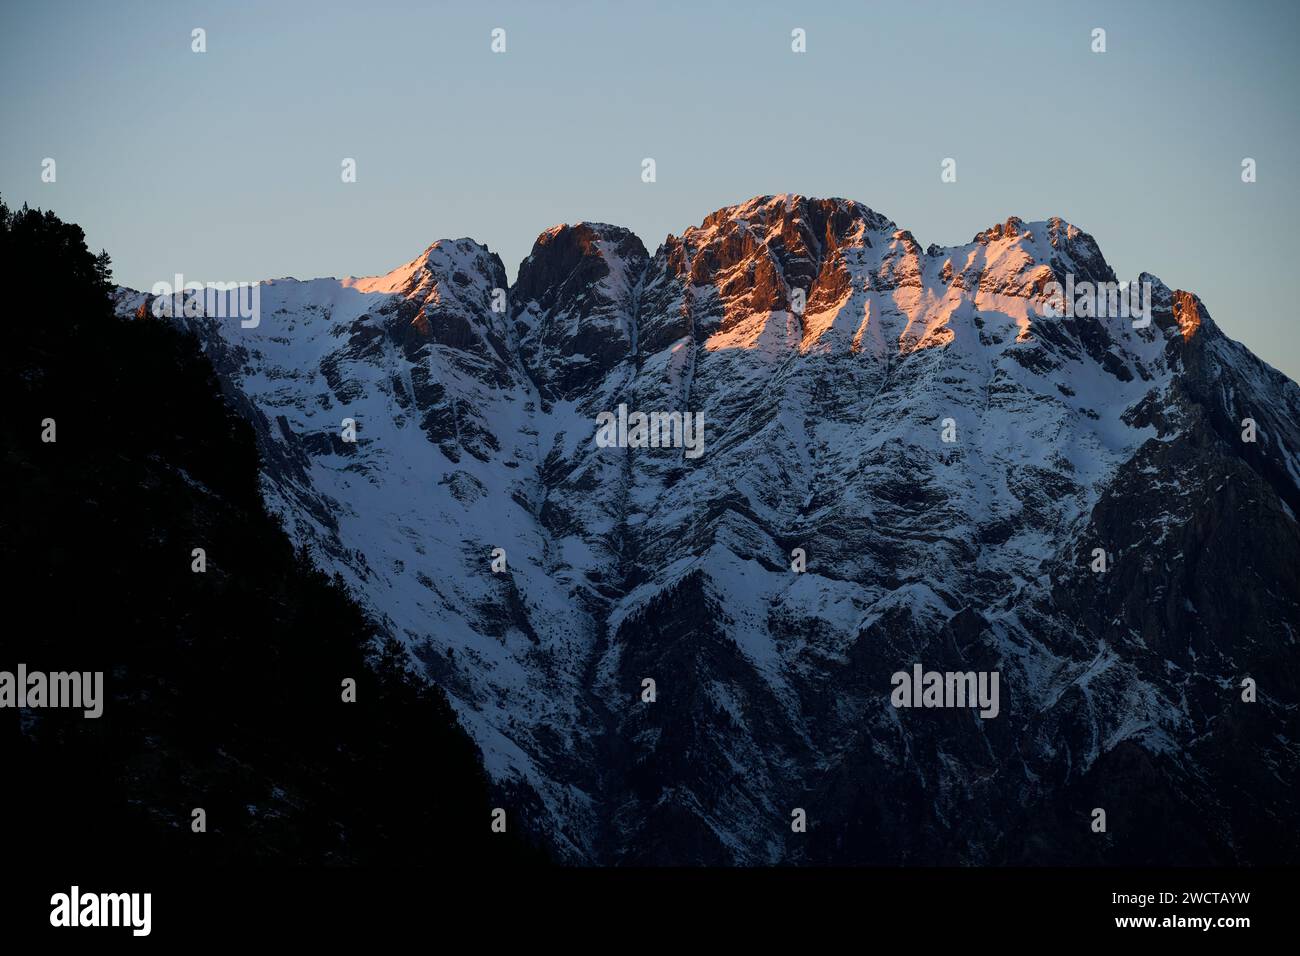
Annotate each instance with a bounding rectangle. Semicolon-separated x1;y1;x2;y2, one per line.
118;195;1300;864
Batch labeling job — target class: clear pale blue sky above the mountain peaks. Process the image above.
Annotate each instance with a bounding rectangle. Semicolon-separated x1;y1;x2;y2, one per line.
0;0;1300;378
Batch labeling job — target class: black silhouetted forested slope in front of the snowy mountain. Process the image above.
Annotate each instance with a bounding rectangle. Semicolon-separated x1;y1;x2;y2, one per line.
0;206;538;866
